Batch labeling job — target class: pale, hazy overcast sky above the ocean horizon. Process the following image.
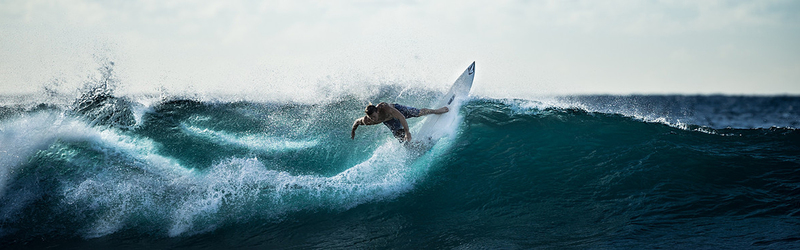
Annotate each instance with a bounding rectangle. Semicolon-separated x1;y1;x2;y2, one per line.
0;0;800;98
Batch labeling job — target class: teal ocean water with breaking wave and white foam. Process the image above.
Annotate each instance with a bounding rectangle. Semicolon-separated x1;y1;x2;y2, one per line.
0;81;800;249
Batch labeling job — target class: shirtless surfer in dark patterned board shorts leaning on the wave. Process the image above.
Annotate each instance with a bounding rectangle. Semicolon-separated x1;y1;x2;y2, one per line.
350;102;450;142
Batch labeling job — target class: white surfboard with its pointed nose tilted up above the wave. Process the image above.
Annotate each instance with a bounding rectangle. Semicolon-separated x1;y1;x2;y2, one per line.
413;62;475;146
